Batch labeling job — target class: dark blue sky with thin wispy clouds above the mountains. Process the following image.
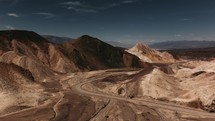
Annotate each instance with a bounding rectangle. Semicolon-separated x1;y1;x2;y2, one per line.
0;0;215;43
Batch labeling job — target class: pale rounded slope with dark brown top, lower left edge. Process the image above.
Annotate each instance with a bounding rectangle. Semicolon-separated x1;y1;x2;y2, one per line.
0;62;44;115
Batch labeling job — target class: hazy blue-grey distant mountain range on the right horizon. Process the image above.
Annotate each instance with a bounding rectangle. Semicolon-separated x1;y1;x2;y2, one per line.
149;40;215;50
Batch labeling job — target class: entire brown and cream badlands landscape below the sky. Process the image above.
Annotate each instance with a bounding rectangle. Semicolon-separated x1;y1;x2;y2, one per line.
0;30;215;121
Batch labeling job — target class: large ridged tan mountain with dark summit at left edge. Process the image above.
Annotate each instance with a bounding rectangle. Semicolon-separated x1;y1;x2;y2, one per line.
0;30;79;79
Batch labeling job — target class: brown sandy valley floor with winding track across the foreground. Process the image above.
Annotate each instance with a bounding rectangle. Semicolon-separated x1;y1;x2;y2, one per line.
0;69;215;121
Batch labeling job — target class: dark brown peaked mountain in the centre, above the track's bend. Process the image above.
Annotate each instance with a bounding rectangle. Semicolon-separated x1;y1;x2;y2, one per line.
64;35;145;70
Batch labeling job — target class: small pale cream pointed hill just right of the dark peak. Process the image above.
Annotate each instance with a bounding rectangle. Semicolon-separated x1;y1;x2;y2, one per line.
126;43;175;63
